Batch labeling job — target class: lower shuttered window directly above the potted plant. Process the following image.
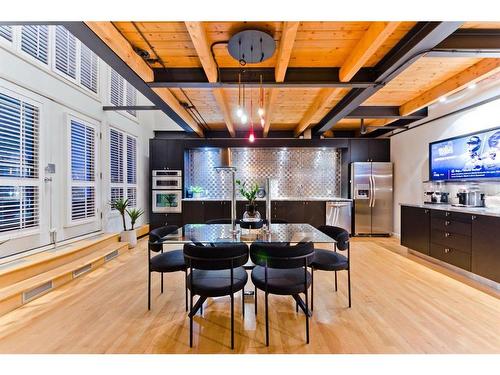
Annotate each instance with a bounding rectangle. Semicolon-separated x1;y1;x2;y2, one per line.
109;128;137;212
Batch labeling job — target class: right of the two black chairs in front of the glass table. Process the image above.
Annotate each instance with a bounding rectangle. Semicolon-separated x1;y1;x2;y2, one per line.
250;242;314;346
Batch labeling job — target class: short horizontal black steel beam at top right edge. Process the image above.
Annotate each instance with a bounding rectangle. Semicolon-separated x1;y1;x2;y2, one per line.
427;29;500;58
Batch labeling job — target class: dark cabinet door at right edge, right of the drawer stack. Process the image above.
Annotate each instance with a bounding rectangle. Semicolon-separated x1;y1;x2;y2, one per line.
472;215;500;282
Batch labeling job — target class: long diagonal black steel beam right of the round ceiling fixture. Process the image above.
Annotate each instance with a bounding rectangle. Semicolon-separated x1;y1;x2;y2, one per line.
313;22;462;134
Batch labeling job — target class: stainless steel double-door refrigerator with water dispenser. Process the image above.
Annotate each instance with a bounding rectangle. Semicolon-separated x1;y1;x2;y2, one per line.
351;162;393;235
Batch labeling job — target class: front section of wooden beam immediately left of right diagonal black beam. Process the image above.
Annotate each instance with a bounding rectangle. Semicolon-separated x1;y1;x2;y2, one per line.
339;22;400;82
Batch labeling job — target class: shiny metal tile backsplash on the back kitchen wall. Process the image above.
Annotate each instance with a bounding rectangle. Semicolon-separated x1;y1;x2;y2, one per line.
185;148;341;199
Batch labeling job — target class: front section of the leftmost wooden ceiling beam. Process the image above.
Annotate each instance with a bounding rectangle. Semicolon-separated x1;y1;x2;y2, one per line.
85;22;154;82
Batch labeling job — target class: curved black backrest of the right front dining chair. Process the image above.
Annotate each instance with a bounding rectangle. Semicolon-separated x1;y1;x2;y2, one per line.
250;242;314;268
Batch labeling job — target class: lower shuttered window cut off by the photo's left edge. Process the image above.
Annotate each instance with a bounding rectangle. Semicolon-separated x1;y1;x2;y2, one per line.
0;92;40;236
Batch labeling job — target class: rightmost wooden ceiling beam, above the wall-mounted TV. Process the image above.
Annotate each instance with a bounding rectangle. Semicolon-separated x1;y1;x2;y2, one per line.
399;59;500;116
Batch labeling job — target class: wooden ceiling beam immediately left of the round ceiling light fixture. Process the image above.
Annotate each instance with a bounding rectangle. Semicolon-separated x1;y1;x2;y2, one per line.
184;22;236;137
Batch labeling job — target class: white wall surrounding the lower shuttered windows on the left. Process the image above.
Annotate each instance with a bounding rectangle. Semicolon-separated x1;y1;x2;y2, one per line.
0;29;172;257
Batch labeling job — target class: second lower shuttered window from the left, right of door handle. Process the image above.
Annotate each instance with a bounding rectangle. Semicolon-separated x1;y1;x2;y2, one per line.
70;118;96;222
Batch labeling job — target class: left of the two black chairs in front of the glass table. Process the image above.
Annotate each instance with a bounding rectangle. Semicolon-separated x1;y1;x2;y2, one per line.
184;242;248;349
